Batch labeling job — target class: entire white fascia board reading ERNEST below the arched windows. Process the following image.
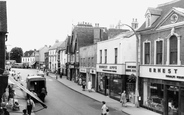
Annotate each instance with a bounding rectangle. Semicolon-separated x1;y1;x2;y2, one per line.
140;66;184;81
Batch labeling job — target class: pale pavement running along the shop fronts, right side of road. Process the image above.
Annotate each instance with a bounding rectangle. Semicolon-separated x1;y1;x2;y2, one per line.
49;73;161;115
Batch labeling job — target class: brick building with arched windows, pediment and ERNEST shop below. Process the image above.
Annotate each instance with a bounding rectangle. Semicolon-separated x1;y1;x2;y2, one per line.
137;0;184;115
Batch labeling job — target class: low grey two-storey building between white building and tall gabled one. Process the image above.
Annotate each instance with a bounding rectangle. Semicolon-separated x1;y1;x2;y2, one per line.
77;44;97;90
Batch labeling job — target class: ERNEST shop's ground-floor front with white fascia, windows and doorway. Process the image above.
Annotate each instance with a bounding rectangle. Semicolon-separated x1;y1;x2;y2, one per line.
140;66;184;115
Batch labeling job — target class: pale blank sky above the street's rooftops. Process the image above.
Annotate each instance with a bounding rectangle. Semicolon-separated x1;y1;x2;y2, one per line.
5;0;172;52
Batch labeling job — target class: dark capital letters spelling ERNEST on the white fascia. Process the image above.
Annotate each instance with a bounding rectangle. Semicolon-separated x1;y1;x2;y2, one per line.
149;68;178;74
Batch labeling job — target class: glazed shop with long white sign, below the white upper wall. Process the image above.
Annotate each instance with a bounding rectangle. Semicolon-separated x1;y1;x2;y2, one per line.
97;64;126;100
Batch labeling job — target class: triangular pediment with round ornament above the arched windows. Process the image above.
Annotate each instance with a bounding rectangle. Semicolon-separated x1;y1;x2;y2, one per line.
156;8;184;28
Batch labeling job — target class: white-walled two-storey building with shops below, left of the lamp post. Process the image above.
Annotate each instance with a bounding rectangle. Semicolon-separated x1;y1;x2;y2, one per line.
96;31;136;103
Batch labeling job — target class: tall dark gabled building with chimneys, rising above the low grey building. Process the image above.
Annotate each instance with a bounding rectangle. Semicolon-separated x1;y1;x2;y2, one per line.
66;23;107;82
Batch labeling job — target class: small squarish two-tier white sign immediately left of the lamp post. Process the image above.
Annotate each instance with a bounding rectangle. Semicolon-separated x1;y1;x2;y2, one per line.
125;62;136;75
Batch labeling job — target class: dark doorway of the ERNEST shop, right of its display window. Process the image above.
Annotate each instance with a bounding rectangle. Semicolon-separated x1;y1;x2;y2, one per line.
167;85;179;115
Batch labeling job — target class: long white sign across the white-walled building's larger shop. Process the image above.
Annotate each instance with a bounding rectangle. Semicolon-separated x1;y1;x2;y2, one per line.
96;64;125;74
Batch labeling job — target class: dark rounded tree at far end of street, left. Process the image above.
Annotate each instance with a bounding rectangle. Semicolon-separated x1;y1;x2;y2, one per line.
10;47;23;63
